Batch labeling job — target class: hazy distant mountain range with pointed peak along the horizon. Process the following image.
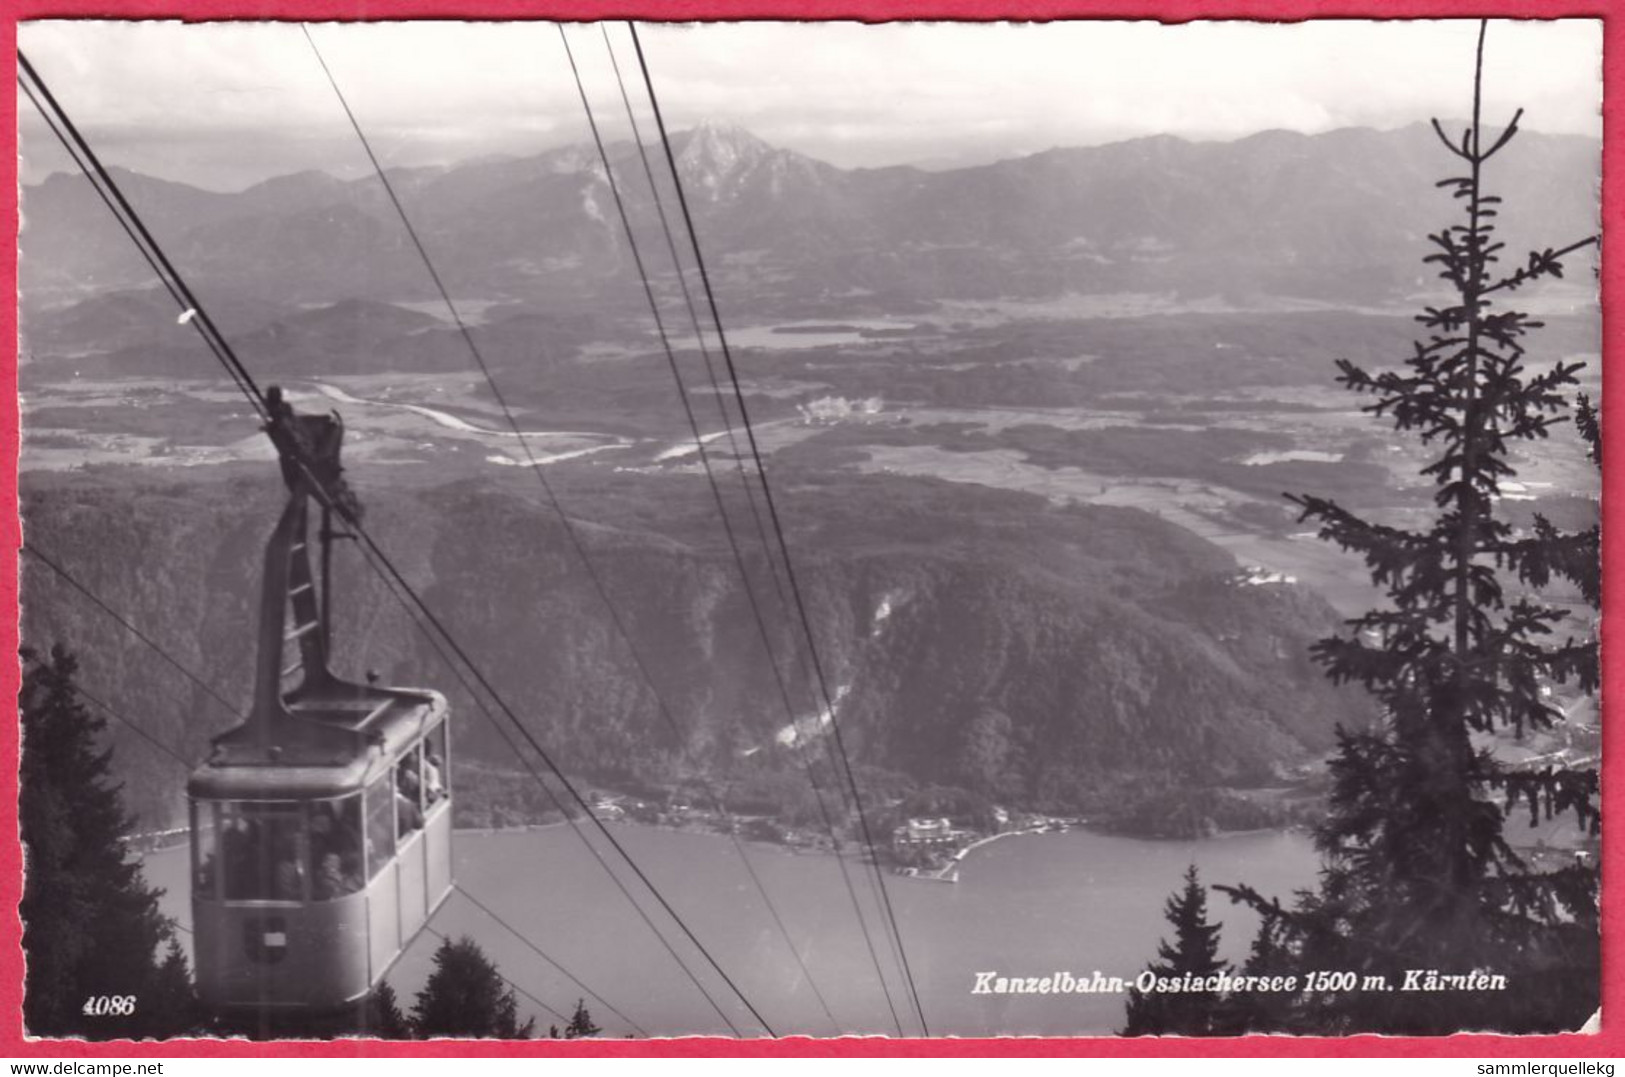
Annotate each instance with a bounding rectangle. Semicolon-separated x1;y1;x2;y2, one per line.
21;123;1599;330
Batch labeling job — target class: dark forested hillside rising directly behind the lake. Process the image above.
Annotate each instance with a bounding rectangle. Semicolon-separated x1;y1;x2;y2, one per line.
23;469;1367;825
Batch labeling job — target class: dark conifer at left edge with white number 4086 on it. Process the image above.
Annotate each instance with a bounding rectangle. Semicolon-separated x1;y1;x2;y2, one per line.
18;645;197;1040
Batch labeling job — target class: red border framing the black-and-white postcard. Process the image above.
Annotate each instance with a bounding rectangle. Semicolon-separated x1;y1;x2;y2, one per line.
0;0;1625;1058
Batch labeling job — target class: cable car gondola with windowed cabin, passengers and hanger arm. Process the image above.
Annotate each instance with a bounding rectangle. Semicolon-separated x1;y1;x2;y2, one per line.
187;388;452;1017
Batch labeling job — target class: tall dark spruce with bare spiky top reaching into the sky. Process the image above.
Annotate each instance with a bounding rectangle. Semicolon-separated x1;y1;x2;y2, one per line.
1230;24;1599;1033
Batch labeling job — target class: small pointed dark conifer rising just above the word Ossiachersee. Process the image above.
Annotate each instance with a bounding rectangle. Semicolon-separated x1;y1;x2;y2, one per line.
1123;864;1229;1036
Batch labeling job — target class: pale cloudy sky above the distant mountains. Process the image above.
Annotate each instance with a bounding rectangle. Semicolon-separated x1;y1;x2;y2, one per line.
20;19;1602;188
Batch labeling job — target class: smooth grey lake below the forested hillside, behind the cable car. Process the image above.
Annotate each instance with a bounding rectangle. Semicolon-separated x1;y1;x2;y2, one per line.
146;825;1320;1036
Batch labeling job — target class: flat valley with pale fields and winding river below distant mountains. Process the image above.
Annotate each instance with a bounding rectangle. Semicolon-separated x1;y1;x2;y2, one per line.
23;296;1597;623
